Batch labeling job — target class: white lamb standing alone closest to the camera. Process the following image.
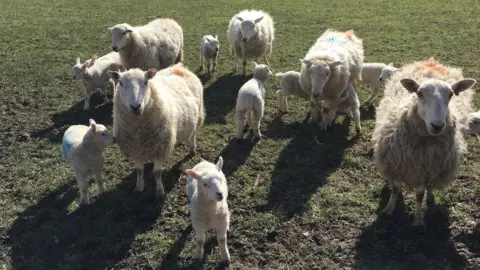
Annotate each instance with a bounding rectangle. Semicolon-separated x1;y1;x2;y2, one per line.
185;156;230;263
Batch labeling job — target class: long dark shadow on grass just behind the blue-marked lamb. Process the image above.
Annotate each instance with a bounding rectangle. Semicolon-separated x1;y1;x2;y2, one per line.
31;94;113;142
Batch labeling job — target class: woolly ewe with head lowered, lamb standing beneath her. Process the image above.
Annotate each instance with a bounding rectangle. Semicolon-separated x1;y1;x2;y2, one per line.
300;29;364;130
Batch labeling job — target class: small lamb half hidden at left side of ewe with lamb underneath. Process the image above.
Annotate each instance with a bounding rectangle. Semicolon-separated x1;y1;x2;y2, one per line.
275;71;310;113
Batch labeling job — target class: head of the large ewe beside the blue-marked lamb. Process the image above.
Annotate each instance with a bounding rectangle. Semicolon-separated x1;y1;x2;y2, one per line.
107;68;157;115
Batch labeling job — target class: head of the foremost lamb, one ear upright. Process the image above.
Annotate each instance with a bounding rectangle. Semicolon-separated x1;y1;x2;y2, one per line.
186;157;228;201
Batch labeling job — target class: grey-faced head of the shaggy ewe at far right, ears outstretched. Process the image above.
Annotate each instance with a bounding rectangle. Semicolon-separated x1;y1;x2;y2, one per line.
400;78;476;136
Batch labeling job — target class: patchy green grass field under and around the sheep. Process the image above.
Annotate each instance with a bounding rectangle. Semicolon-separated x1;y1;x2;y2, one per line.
0;0;480;270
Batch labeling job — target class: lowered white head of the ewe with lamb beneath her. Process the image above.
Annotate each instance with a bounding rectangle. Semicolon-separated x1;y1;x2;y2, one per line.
300;59;343;97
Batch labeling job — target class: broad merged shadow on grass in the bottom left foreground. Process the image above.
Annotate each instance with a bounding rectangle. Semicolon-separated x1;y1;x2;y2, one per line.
7;167;172;269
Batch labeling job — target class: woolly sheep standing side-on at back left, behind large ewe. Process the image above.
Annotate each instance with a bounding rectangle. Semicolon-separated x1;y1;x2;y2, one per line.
108;18;183;70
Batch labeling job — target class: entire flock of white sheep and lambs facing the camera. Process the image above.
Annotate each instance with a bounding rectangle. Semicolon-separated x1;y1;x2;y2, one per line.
62;10;480;262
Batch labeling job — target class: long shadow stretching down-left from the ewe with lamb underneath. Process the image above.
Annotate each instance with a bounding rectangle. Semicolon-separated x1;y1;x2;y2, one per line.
257;119;357;219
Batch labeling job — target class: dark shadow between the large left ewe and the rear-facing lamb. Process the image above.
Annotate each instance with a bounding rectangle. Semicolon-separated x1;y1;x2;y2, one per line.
203;75;249;124
